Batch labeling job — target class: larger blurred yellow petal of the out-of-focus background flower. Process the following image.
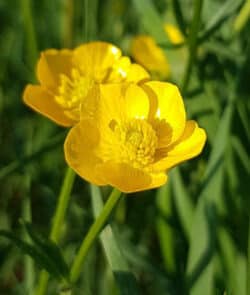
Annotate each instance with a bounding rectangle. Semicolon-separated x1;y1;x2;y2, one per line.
131;35;169;78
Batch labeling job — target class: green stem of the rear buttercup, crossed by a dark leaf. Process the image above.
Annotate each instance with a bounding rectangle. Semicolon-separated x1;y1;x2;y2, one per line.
35;167;75;295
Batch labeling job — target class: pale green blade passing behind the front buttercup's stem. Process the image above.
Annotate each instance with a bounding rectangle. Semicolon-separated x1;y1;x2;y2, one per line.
91;185;139;295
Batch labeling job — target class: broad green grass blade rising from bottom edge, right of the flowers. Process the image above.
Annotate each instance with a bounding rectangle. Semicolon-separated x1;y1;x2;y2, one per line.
187;102;233;295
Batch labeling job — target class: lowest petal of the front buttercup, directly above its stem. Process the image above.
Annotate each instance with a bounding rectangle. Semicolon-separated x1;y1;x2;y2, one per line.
98;162;167;193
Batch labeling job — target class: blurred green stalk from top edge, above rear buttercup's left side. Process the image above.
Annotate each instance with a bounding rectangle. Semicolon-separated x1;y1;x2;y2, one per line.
21;0;38;68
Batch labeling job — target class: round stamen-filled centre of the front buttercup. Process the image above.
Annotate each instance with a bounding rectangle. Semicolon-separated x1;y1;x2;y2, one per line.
110;119;158;168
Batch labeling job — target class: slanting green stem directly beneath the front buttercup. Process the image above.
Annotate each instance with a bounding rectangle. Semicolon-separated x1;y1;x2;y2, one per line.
70;188;121;284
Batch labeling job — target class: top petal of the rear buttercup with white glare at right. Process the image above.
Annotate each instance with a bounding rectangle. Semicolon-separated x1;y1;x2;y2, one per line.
74;42;121;82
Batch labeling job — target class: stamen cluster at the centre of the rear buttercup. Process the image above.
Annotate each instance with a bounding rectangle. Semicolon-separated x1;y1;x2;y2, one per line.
55;69;94;121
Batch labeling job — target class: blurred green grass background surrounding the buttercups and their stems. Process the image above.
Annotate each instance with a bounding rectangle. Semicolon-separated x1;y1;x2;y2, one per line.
0;0;250;295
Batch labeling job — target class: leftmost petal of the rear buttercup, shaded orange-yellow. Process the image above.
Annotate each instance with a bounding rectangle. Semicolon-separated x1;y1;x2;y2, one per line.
23;85;76;127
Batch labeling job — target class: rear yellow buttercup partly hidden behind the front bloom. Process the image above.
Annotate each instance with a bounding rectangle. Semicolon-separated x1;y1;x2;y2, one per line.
24;42;149;126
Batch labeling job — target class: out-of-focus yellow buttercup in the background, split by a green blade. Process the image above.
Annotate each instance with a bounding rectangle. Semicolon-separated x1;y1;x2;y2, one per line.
131;24;184;79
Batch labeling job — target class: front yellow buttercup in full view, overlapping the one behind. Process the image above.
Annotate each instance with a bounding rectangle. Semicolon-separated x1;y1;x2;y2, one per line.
64;81;206;193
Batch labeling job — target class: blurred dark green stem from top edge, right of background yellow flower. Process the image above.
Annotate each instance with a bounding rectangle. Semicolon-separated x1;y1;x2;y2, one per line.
181;0;203;94
